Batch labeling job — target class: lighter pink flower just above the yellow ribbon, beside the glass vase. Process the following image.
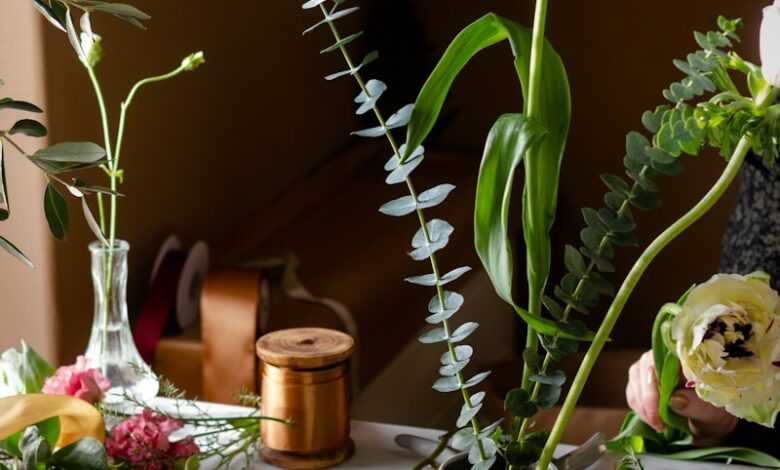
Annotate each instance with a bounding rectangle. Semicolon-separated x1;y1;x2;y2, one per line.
42;356;111;404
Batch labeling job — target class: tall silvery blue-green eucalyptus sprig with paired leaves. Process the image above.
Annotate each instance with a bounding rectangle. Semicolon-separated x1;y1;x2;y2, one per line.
303;0;499;470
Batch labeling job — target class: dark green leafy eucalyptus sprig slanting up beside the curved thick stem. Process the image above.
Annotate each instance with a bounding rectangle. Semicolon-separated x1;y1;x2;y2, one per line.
524;17;747;440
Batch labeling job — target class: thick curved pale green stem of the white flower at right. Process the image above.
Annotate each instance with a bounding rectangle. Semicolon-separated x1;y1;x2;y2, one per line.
537;87;778;470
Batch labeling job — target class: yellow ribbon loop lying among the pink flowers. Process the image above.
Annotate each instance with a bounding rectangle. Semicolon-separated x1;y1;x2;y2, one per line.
0;394;106;449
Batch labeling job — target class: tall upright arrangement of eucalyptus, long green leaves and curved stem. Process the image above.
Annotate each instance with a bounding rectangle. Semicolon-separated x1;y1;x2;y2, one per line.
303;0;780;470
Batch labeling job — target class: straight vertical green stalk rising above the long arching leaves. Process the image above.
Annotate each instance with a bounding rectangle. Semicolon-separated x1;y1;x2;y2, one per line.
522;0;548;404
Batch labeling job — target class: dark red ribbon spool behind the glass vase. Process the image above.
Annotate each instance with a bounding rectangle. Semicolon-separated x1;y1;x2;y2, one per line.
133;236;209;364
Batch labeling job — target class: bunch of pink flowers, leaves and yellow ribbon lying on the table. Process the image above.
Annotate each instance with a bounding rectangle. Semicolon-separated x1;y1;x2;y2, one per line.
0;342;290;470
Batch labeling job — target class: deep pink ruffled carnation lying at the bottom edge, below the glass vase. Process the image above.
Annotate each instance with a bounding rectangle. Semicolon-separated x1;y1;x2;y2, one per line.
106;409;200;470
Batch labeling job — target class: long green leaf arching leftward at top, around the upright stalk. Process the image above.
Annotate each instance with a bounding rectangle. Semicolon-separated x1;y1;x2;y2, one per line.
404;13;571;324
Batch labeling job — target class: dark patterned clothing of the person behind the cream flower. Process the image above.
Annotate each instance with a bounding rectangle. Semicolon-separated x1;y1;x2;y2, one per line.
720;156;780;457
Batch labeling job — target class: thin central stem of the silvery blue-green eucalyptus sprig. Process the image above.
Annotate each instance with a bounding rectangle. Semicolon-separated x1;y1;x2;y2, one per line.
320;4;487;461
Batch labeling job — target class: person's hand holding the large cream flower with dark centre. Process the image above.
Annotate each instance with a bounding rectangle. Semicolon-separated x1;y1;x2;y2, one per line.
626;351;739;446
